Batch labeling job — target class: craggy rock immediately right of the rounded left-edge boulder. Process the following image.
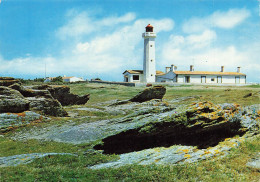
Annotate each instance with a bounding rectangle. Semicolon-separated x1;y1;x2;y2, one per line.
27;97;68;117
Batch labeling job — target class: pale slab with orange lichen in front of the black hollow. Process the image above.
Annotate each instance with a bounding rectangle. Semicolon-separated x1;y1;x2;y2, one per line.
89;138;244;169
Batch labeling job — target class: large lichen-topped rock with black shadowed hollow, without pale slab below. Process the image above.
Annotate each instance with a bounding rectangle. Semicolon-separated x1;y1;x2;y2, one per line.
95;102;259;154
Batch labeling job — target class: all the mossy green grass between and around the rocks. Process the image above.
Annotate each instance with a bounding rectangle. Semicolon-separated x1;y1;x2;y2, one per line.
0;84;260;181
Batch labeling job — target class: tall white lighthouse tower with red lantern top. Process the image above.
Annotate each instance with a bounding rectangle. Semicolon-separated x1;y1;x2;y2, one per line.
142;24;156;83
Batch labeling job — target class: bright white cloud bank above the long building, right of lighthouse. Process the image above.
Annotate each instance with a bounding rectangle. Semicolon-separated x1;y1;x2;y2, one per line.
159;30;260;82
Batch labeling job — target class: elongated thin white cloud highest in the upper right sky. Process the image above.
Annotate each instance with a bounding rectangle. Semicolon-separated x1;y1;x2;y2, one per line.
182;9;250;33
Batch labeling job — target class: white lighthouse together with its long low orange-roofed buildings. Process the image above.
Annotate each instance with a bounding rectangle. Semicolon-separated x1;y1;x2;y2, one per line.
123;24;246;84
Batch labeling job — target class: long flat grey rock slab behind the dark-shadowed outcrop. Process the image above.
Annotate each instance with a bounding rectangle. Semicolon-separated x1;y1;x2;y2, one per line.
13;102;174;144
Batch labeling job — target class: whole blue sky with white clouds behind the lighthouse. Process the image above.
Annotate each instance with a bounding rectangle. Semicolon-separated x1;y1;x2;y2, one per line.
0;0;260;83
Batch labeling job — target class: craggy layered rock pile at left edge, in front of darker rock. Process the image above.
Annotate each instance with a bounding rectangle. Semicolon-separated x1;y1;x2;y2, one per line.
0;83;68;117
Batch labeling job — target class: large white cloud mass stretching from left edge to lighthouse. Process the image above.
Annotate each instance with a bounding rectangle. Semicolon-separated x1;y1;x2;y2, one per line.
0;11;174;80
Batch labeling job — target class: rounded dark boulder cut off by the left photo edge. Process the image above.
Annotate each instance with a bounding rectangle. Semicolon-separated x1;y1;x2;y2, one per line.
0;86;29;113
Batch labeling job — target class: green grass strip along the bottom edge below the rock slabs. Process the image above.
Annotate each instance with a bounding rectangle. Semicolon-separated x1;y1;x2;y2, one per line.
0;135;260;182
